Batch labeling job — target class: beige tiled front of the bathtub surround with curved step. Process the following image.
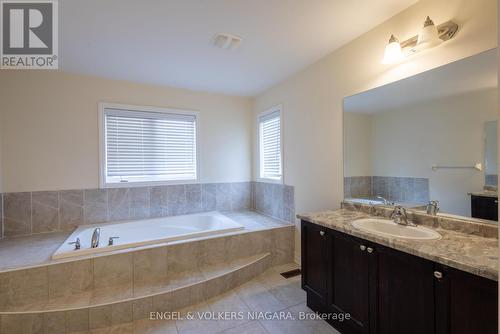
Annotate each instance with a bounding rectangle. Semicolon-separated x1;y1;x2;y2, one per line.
0;211;294;334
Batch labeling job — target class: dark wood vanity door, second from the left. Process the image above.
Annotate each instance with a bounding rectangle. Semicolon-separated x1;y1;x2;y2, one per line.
328;231;370;334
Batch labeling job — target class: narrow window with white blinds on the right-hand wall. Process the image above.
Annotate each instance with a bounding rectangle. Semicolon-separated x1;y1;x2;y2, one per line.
259;107;282;181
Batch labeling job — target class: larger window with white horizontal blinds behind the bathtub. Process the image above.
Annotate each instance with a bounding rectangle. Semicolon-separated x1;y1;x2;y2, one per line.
100;104;198;187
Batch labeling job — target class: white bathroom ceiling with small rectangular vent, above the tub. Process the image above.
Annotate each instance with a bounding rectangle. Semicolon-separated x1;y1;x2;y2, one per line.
59;0;417;96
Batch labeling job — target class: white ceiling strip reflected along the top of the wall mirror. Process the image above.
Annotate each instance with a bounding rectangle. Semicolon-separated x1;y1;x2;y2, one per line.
344;49;498;114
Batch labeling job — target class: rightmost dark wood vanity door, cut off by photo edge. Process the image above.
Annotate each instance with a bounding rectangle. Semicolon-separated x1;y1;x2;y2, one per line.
436;265;498;334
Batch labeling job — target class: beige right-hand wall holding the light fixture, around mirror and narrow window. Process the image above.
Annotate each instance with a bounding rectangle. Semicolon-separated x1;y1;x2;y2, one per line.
254;0;497;259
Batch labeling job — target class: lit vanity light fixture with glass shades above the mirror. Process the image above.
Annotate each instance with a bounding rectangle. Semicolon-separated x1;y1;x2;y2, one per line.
382;16;458;64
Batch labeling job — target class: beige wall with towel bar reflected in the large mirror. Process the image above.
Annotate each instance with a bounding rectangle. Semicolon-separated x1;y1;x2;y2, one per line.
370;89;497;216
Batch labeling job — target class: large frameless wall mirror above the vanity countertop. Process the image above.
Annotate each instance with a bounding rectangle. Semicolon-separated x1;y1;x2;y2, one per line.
343;50;498;221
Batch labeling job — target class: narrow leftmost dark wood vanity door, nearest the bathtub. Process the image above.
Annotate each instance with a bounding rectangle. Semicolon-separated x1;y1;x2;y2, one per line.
301;221;328;305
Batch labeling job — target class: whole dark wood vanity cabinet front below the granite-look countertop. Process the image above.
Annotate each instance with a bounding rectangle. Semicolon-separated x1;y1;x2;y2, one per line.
301;221;498;334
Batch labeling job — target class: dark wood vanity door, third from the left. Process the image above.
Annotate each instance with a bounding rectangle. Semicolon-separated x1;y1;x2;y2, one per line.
374;246;435;334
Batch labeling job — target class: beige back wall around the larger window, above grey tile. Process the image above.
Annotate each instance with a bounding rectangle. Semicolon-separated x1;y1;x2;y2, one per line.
0;71;252;192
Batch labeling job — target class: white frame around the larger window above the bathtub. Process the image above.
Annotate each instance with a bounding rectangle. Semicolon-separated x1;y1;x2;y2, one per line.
98;102;200;189
